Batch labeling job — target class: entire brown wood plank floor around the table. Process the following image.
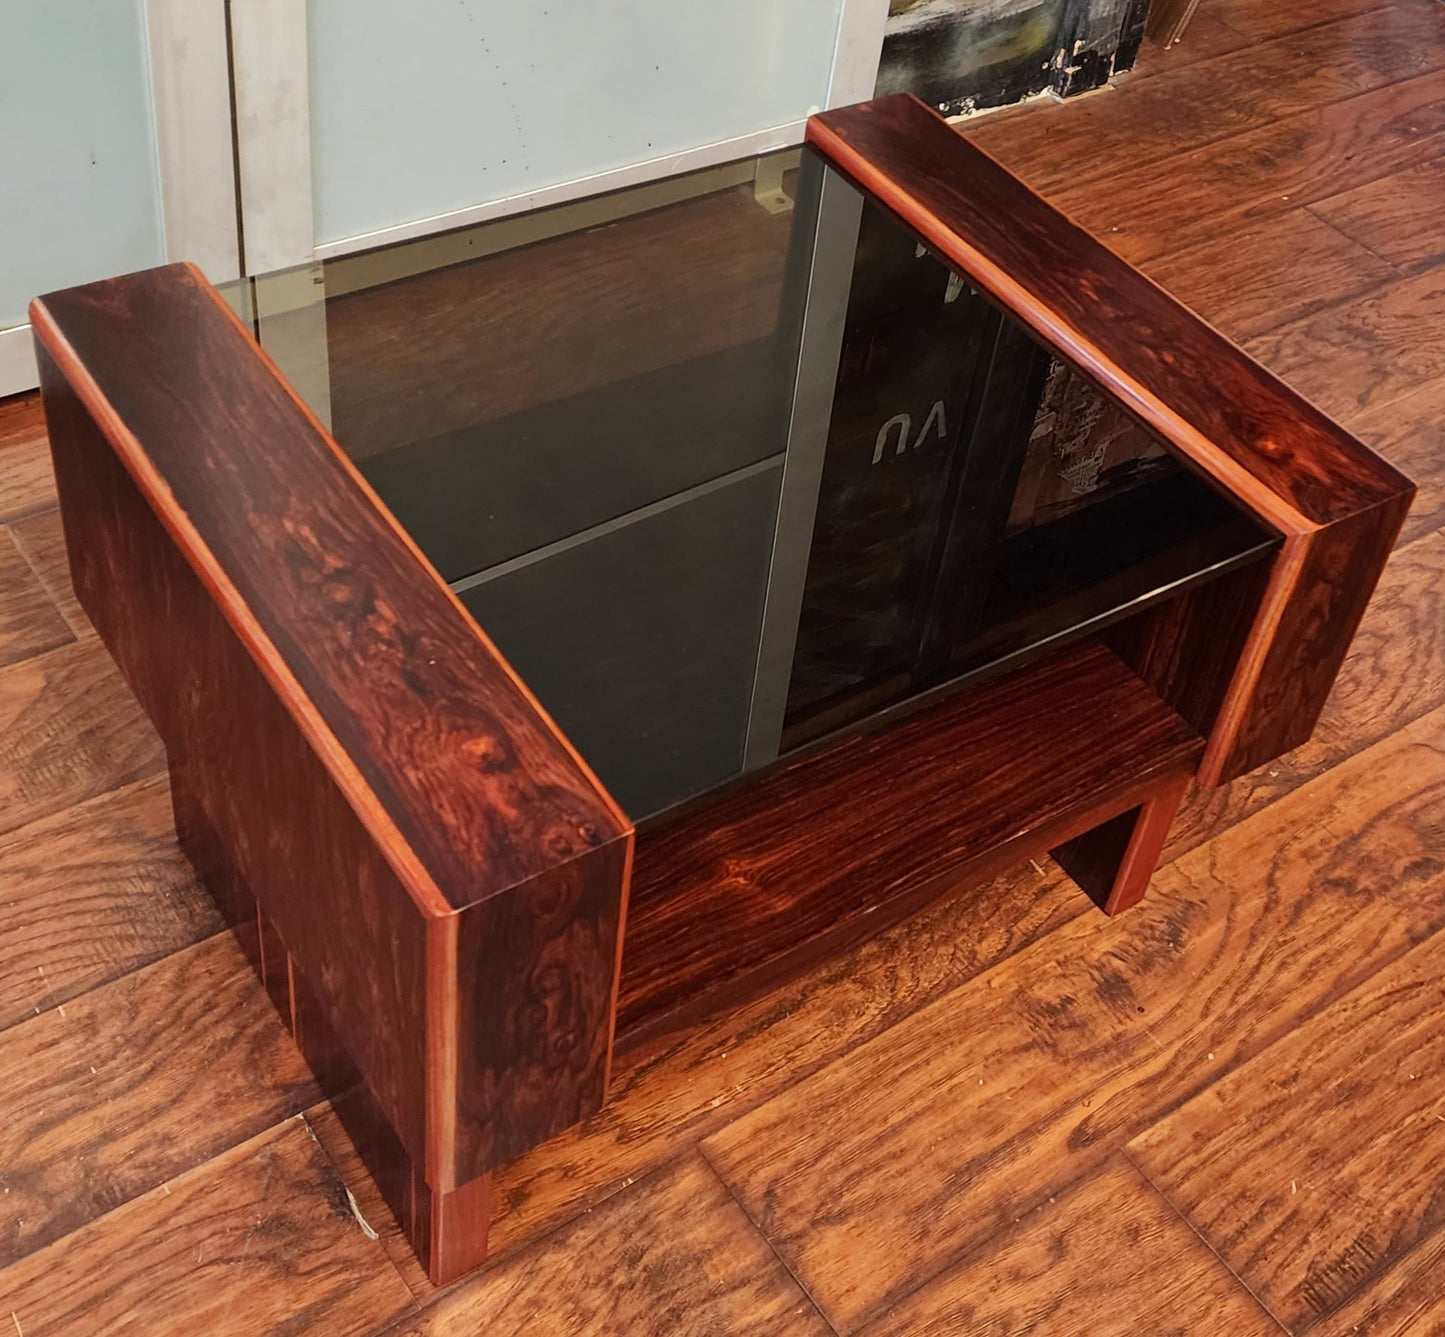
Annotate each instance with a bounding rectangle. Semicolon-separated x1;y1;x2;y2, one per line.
0;0;1445;1337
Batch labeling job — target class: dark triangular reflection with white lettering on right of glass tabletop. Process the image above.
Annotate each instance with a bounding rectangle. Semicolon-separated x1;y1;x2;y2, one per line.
782;189;1267;750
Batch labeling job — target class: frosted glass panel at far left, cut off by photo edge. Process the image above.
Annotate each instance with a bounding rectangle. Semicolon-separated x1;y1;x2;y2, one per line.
0;0;163;328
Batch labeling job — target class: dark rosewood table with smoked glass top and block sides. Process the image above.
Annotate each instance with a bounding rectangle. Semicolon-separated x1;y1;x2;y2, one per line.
32;97;1413;1282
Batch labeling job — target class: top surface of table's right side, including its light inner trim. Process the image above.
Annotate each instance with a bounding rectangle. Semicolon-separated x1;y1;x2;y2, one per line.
808;95;1416;530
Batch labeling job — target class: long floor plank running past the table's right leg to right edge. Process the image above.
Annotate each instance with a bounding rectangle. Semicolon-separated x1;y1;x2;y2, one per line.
704;711;1445;1333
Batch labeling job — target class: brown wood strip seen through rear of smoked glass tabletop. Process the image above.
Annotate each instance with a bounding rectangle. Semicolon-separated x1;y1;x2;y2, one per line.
327;188;790;457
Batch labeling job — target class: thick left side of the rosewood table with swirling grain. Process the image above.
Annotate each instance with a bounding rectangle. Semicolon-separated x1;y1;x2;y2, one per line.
33;267;630;1279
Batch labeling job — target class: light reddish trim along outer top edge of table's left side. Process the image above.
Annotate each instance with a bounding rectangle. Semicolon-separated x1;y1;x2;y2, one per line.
29;298;452;918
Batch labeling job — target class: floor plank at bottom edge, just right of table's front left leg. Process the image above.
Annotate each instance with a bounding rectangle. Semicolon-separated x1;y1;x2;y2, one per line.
392;1153;831;1337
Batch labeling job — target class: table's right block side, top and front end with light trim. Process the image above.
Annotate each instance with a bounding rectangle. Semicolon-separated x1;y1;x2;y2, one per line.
808;97;1413;785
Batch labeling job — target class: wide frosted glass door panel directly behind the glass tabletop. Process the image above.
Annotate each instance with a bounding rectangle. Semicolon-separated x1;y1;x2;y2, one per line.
308;0;842;244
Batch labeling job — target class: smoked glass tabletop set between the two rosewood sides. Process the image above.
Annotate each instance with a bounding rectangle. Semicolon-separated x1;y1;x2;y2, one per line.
236;150;1277;821
